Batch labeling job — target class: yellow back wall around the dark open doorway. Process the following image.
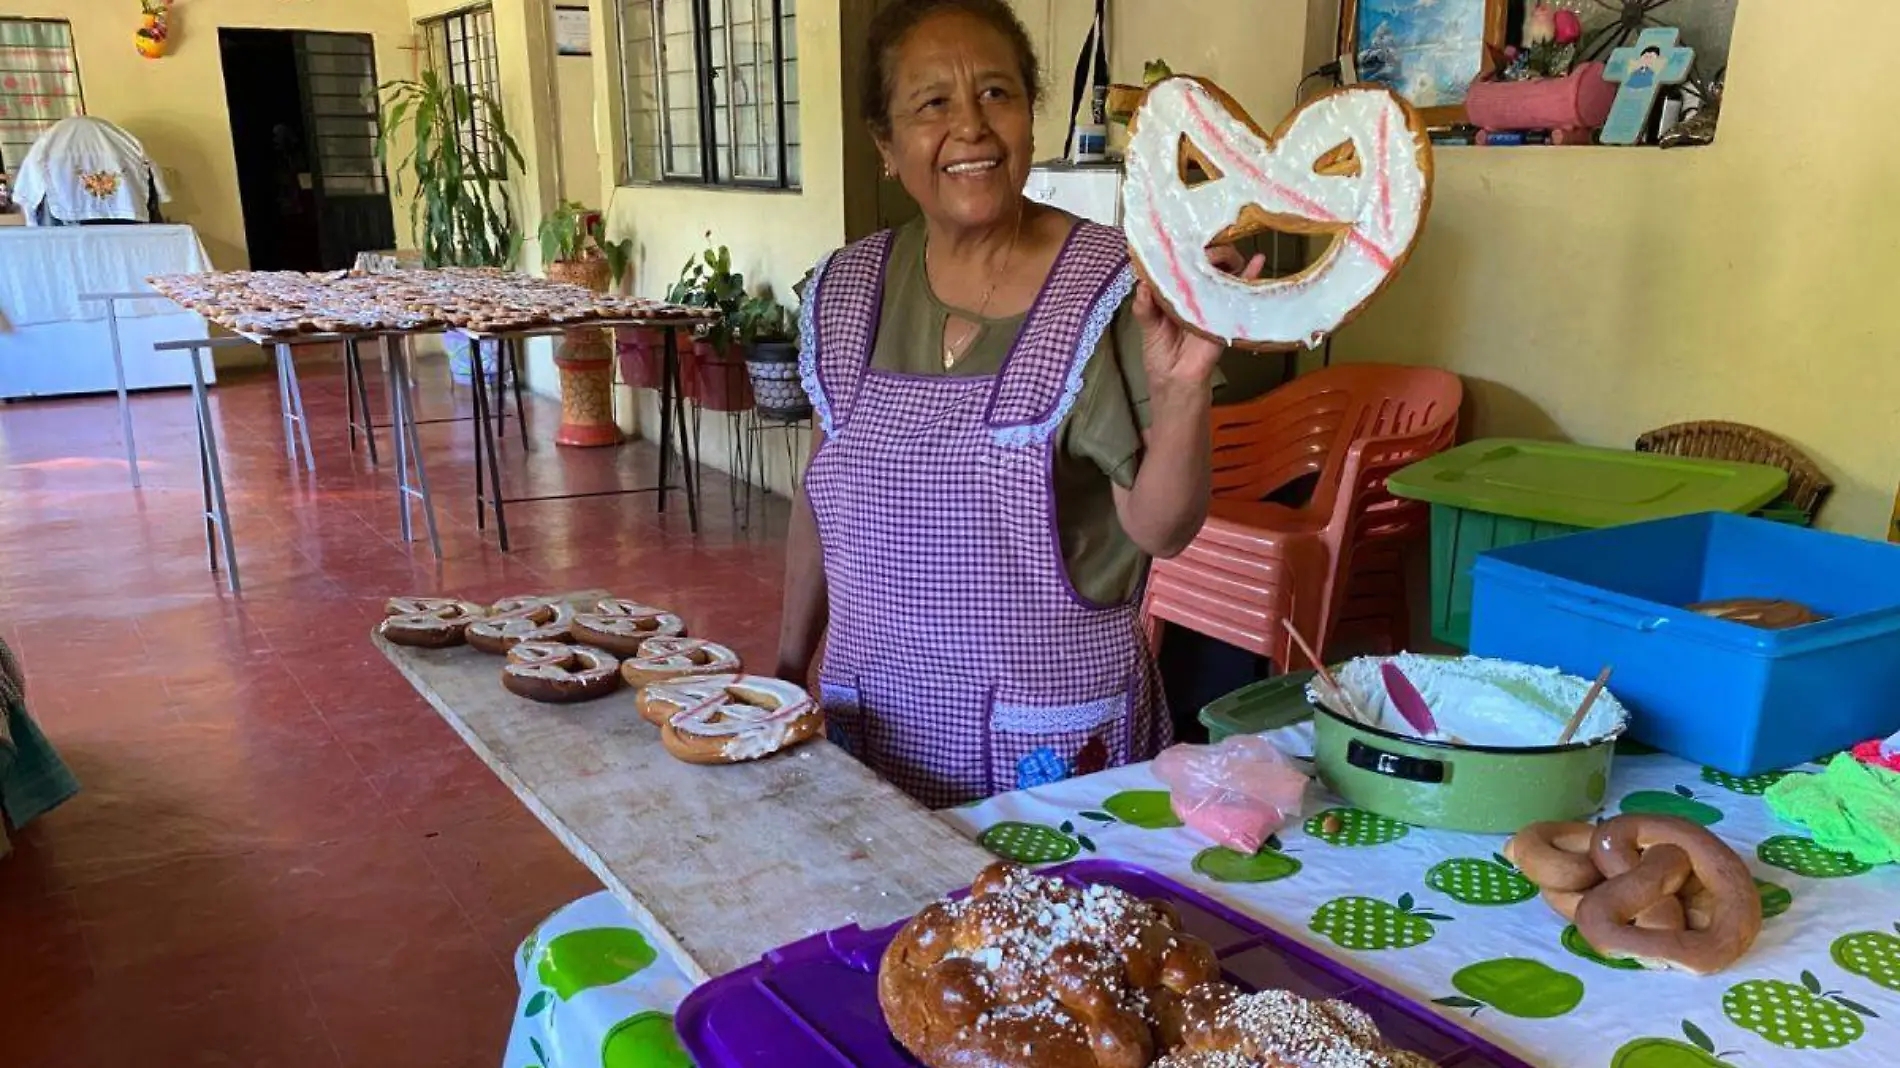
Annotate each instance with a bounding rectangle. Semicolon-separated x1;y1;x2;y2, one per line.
0;0;414;270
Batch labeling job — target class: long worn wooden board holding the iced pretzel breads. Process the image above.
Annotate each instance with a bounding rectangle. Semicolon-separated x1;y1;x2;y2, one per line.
372;595;992;981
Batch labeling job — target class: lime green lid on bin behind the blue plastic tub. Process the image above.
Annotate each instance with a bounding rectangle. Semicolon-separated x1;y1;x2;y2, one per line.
1387;439;1788;528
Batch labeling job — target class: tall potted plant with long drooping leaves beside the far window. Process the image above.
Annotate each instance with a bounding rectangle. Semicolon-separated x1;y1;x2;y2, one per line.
376;70;526;382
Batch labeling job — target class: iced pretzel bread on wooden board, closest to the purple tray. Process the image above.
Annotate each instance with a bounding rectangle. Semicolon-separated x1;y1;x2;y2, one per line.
640;675;825;764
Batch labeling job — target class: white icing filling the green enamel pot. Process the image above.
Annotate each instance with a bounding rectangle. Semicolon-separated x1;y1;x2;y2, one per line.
1307;654;1628;749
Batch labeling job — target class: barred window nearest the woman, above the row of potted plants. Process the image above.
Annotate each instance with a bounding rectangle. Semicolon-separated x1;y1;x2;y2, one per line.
618;0;802;188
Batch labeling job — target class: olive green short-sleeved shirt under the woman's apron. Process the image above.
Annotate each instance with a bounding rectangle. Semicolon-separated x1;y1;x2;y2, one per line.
870;220;1148;604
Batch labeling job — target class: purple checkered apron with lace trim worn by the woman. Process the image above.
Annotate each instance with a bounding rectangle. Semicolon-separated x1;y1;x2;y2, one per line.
802;224;1170;808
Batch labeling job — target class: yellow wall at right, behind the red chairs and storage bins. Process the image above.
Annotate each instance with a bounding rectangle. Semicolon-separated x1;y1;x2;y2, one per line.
1336;0;1900;536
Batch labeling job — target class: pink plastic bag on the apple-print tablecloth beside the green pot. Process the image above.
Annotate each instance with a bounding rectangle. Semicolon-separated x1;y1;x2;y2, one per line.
1155;734;1307;855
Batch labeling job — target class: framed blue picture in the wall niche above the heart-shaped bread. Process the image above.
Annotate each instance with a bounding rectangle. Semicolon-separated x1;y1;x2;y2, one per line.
1340;0;1511;125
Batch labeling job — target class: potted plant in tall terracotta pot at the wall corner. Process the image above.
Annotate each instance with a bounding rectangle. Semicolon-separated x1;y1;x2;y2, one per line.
540;200;633;447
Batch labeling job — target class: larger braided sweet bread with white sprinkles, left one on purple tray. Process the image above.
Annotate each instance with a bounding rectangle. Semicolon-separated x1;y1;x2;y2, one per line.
878;863;1220;1068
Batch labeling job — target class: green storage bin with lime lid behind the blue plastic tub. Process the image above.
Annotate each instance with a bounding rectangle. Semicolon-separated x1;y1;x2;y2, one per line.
1387;439;1788;648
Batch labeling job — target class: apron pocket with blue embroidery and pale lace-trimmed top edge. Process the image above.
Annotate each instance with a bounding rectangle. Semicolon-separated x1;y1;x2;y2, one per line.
990;694;1129;792
